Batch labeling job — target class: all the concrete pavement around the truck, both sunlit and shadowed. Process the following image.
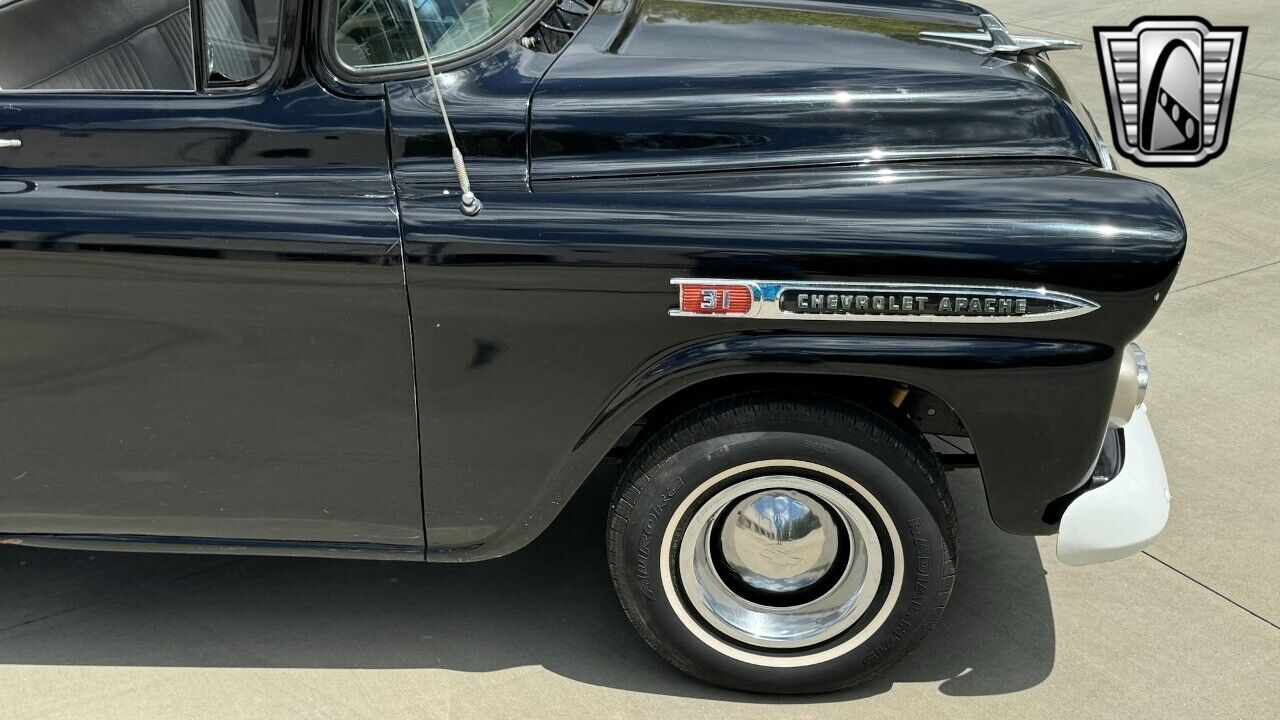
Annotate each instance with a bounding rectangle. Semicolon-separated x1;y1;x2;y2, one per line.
0;0;1280;720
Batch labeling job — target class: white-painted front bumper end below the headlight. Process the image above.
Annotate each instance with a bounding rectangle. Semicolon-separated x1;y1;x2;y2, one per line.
1057;405;1170;565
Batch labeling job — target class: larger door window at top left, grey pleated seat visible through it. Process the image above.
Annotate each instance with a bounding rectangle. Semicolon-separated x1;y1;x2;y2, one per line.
0;0;195;90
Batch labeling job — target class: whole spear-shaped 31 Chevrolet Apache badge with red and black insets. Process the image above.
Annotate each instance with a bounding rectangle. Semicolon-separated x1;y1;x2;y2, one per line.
671;278;1098;323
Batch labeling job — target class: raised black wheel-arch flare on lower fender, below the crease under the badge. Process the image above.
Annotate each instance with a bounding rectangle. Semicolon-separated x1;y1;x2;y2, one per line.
434;332;1117;560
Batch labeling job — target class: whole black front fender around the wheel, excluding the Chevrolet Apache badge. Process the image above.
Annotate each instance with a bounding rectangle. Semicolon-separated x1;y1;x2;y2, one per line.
402;163;1187;560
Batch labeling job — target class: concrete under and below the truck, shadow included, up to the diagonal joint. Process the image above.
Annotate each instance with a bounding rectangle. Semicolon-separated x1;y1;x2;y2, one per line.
0;473;1280;720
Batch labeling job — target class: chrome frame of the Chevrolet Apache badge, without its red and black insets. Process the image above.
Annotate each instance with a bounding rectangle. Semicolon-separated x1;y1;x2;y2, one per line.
668;278;1101;324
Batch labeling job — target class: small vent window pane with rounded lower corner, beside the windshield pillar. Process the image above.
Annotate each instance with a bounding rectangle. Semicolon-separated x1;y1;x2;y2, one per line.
200;0;280;87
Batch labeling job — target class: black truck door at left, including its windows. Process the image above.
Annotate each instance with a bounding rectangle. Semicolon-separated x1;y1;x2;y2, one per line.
0;0;422;556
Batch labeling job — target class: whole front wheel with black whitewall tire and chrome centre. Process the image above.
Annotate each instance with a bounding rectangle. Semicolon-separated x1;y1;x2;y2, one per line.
608;396;956;693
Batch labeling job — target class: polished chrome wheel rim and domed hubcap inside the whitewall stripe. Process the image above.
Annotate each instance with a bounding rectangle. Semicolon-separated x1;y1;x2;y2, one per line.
678;475;884;650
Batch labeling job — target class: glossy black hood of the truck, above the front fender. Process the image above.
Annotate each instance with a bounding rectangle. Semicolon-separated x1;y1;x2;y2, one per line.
530;0;1097;179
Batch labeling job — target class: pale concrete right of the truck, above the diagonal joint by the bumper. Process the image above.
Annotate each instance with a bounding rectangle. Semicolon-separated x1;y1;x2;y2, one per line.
1003;0;1280;624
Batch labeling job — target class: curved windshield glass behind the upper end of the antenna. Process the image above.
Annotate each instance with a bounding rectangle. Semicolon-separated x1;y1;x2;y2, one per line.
334;0;534;69
